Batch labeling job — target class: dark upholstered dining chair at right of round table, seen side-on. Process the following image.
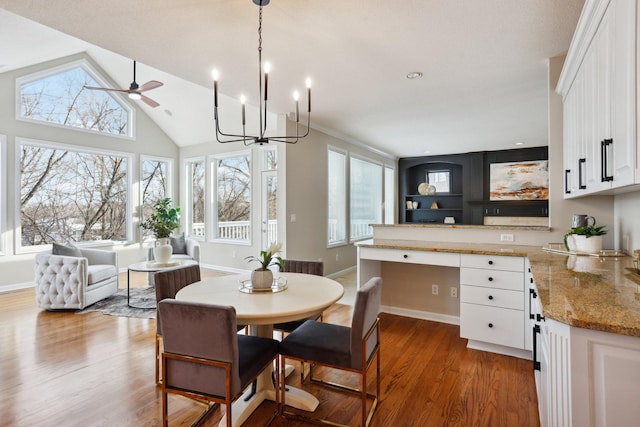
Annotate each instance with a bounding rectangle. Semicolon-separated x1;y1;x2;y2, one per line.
280;277;382;427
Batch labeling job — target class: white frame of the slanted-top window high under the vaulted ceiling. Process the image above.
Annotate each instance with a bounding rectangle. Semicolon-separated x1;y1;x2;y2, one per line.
15;59;136;140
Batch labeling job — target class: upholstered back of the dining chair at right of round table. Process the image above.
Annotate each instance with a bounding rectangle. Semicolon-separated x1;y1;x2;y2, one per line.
351;277;382;369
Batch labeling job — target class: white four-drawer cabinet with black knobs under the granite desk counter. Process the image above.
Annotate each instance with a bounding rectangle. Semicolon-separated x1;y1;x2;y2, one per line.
460;254;528;354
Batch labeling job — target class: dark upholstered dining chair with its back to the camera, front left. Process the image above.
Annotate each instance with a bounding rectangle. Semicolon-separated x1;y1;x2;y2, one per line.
158;299;280;427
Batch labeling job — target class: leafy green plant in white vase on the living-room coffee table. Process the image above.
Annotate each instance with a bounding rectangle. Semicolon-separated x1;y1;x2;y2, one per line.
140;197;180;264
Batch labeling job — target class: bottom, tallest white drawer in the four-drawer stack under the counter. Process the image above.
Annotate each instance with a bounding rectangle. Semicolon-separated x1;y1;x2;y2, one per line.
460;303;524;349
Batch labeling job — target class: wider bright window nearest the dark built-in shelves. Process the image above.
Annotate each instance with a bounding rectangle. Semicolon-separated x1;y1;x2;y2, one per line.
349;156;382;240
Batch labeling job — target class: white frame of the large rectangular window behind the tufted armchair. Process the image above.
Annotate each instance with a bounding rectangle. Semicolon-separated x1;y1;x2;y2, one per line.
14;137;135;254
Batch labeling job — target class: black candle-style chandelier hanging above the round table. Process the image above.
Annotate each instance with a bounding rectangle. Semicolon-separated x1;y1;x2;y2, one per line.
212;0;311;145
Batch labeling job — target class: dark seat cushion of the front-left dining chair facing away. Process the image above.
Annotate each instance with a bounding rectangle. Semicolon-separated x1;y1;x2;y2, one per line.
238;335;278;389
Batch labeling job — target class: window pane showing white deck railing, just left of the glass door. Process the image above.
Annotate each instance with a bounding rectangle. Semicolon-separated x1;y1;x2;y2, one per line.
213;152;251;243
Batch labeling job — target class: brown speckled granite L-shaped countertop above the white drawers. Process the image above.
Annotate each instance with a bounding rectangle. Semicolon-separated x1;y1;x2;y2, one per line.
358;240;640;337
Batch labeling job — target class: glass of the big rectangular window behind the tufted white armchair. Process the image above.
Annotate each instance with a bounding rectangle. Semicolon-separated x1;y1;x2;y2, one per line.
18;140;131;247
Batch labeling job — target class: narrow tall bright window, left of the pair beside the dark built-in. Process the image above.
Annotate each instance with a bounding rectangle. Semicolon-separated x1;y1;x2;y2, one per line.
327;148;347;246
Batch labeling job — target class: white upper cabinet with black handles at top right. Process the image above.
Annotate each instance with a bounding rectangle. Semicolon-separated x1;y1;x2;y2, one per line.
556;0;640;198
